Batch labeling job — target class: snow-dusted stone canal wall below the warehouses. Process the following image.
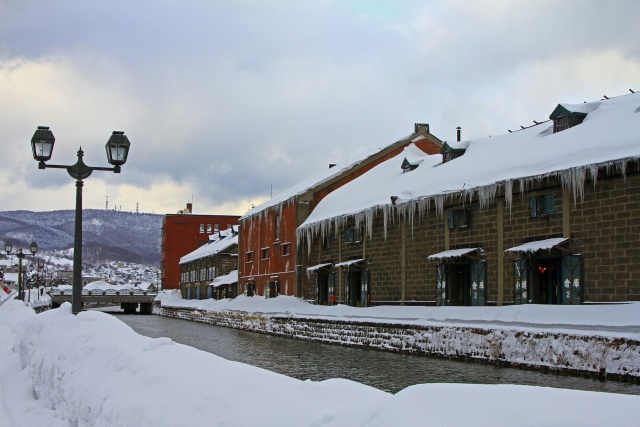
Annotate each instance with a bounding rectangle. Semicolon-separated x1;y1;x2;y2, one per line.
160;306;640;383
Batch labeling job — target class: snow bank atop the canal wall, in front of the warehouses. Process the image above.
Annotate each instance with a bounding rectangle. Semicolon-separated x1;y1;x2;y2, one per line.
158;291;640;340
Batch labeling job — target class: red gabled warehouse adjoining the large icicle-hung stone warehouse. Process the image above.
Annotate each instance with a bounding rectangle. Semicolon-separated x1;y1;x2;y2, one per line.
238;124;443;298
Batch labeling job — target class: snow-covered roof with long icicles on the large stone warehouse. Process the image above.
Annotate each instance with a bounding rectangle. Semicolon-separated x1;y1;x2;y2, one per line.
297;93;640;241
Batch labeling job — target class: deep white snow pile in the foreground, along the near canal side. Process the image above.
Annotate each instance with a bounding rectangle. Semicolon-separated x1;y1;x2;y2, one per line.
0;301;640;427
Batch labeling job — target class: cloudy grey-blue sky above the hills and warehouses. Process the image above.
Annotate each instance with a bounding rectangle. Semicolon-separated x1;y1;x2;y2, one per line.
0;0;640;214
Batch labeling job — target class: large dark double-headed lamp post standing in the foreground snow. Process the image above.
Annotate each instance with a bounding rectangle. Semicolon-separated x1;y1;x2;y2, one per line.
31;126;131;314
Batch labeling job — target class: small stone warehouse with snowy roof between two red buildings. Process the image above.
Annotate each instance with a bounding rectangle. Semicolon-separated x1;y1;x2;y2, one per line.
180;225;238;299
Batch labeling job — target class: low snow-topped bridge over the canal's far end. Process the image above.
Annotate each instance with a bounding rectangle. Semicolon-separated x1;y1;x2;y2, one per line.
49;290;158;314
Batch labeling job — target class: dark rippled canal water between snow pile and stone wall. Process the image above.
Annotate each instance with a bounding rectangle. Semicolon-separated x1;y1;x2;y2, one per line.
115;314;640;395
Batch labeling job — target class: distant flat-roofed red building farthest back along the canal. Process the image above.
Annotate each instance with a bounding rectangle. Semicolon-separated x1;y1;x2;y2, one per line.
160;203;239;289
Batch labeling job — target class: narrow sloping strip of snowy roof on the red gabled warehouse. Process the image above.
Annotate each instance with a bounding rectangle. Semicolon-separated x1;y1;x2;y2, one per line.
240;132;440;220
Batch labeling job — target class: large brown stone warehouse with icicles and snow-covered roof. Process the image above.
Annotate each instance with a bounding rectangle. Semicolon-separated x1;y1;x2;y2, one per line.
297;93;640;306
